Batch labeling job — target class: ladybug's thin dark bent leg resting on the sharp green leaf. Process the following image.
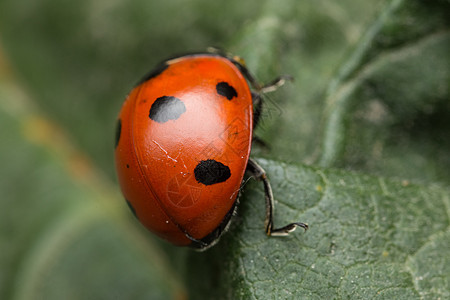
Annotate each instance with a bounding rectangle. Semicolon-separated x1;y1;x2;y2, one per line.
247;158;308;236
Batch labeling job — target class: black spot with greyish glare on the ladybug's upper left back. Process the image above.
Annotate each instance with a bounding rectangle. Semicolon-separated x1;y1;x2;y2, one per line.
148;96;186;123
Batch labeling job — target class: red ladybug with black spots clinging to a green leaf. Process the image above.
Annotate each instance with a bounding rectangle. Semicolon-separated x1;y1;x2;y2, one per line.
115;51;308;249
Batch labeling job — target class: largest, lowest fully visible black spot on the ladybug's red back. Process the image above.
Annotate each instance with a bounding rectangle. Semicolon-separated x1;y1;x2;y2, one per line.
194;159;231;185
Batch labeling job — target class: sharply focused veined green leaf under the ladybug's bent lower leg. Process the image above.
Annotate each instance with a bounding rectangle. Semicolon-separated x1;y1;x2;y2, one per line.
187;160;450;299
